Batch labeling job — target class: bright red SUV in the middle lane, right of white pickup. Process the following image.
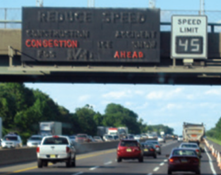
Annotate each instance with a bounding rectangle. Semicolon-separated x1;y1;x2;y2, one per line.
117;140;143;162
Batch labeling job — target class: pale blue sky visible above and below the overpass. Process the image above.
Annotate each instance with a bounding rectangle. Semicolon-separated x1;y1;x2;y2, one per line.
0;0;221;134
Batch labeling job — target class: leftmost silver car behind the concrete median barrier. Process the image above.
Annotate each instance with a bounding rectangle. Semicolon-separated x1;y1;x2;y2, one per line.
1;134;22;148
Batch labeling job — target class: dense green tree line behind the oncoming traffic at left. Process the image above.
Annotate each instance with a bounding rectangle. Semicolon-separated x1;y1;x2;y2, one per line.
0;83;173;140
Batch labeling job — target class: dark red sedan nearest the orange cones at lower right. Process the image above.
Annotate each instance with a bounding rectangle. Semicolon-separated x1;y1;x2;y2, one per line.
167;148;200;174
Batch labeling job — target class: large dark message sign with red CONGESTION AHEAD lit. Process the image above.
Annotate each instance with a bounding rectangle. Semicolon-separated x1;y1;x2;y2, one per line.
22;7;160;63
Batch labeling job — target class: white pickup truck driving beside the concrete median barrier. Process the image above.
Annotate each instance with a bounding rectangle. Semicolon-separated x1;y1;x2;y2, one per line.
36;135;76;168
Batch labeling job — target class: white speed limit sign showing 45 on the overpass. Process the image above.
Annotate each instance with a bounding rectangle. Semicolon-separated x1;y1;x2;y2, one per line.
171;16;207;59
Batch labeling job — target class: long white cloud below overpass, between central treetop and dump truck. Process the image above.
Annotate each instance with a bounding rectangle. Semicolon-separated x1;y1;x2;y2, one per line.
147;88;182;100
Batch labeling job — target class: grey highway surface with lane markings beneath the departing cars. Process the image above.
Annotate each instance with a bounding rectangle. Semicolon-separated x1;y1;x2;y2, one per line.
0;141;218;175
